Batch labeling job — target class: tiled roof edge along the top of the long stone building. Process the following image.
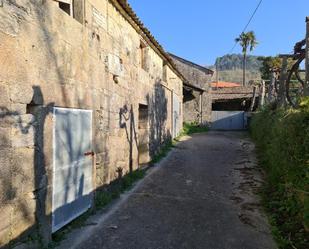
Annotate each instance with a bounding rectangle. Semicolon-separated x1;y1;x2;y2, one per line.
110;0;188;82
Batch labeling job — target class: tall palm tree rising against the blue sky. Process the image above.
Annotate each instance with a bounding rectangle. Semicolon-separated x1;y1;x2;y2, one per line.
235;31;258;86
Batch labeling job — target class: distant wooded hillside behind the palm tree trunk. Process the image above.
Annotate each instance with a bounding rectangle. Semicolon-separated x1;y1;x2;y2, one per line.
210;54;262;83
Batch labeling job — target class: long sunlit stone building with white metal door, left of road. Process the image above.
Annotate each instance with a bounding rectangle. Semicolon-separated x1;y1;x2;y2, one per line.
0;0;185;246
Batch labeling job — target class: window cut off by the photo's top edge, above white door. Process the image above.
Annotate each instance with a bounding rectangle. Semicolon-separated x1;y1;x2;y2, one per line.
55;0;84;24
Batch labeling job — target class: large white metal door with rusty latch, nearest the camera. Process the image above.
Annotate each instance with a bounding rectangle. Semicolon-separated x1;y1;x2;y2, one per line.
52;108;93;232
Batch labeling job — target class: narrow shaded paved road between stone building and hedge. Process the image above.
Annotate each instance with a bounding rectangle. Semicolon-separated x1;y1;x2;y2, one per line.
59;132;276;249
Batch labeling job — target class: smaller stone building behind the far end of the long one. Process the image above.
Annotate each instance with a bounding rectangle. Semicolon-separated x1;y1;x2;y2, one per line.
169;53;214;124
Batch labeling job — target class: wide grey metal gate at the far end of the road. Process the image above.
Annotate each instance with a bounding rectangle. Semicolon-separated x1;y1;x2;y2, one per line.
211;111;245;130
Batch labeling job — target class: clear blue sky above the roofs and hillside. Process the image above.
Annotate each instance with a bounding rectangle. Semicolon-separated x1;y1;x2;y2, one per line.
128;0;309;65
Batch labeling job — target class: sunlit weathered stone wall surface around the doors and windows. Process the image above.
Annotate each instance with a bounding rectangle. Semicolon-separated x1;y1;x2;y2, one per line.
0;0;182;246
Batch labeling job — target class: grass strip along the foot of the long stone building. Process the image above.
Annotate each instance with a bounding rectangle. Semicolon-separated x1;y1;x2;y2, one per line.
48;123;208;248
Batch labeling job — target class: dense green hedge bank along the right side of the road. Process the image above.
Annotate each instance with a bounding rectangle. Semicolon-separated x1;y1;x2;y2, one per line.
251;106;309;249
